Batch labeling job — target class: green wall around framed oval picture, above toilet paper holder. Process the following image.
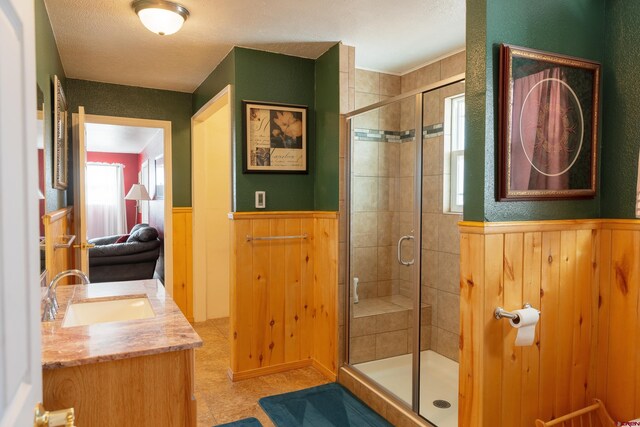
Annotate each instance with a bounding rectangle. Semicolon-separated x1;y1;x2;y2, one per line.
464;0;605;221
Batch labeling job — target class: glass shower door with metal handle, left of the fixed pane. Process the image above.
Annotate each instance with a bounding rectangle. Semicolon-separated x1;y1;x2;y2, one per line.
348;95;421;406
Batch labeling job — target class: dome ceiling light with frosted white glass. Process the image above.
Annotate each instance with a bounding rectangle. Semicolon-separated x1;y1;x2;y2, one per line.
131;0;189;36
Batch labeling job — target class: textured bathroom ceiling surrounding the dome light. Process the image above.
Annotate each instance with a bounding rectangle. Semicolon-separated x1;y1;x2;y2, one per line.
45;0;465;92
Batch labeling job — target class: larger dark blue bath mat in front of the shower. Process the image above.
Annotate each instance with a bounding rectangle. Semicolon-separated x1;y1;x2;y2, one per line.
258;383;391;427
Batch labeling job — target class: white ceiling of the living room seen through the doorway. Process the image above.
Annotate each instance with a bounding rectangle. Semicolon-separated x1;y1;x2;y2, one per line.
85;123;162;154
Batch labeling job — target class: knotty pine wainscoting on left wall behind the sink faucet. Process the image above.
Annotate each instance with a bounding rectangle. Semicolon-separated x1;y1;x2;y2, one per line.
42;207;73;284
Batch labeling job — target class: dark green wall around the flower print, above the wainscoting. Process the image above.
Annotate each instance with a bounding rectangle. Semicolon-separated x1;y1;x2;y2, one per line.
192;44;339;212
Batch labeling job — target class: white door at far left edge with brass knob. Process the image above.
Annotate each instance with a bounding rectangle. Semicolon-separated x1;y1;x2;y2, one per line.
0;0;42;427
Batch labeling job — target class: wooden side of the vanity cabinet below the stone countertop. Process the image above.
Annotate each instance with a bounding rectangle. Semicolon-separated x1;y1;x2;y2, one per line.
43;349;197;427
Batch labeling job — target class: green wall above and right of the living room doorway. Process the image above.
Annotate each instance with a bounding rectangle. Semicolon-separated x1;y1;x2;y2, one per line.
67;79;192;206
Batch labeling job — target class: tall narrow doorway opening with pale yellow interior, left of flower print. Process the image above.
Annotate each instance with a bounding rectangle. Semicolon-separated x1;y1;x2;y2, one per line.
191;86;233;322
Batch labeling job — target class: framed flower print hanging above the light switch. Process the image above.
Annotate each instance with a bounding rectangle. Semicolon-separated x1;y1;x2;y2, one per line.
242;101;308;173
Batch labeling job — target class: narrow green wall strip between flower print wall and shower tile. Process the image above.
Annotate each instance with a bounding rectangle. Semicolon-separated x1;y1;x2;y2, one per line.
314;44;340;211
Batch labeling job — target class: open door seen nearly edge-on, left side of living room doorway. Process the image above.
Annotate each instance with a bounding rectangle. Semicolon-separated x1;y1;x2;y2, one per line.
73;107;90;276
